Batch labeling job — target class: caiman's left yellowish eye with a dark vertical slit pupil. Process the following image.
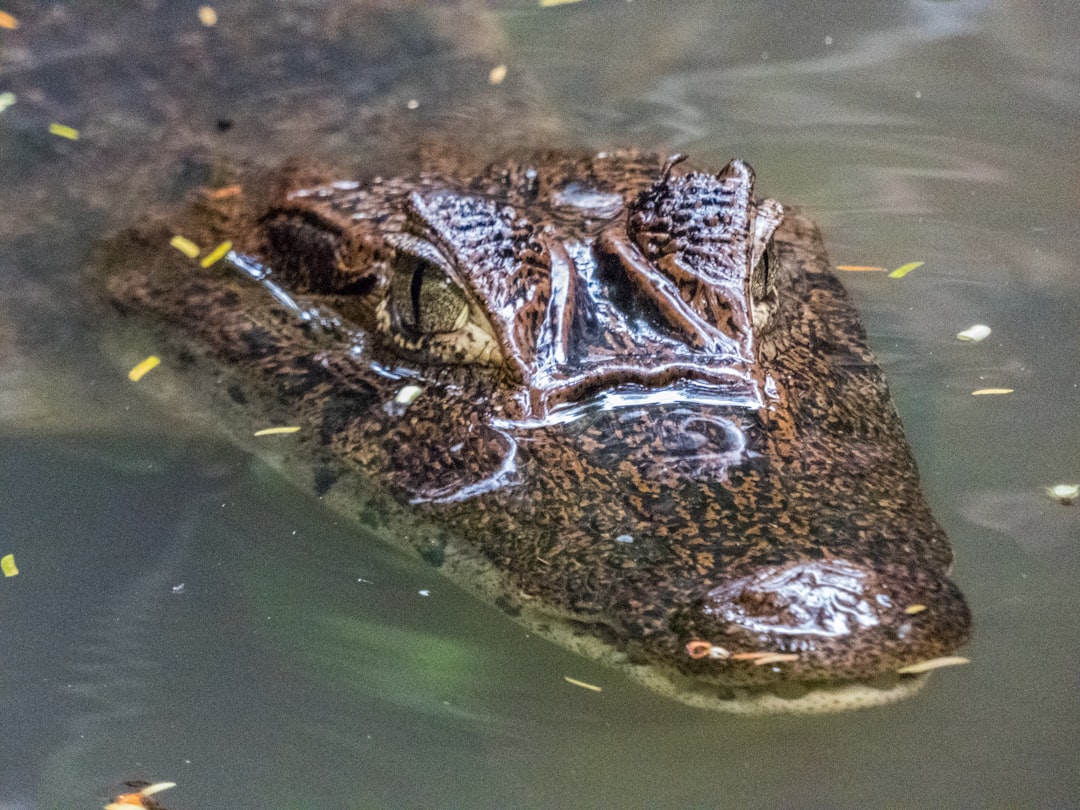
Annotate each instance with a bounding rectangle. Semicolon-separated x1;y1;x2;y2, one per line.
390;249;469;335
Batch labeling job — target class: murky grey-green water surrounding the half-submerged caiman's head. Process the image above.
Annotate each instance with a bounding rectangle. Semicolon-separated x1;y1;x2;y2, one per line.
0;0;1080;810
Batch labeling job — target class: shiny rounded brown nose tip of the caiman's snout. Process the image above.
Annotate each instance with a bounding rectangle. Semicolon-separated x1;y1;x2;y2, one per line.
687;558;971;680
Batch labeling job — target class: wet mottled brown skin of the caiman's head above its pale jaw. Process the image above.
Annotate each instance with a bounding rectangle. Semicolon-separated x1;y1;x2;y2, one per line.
101;153;970;688
